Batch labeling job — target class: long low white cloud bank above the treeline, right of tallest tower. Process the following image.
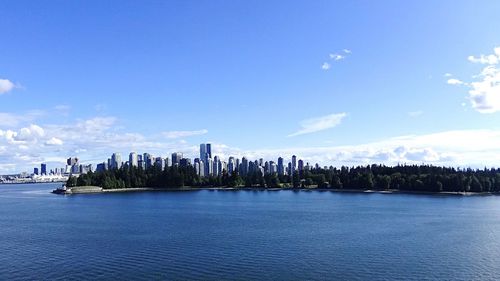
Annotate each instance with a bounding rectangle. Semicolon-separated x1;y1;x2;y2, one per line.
212;130;500;168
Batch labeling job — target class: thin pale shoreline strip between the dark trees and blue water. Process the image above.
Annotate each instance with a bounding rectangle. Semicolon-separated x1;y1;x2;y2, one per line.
52;186;500;196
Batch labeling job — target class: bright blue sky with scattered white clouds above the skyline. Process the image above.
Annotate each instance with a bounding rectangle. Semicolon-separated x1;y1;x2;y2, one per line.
0;0;500;174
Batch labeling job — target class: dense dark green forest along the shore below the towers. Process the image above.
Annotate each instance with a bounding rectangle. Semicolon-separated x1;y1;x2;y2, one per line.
67;165;500;192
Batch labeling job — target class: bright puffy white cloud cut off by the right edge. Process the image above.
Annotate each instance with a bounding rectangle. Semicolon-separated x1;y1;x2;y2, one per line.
447;47;500;113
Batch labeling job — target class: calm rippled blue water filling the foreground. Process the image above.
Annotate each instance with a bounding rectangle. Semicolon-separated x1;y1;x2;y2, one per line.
0;184;500;280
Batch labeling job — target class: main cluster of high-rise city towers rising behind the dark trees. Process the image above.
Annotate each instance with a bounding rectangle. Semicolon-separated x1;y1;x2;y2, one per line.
96;143;319;177
